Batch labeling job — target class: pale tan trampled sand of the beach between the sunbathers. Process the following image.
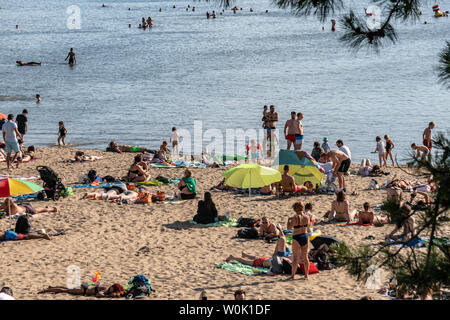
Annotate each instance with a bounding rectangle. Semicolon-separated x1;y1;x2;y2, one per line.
0;147;449;300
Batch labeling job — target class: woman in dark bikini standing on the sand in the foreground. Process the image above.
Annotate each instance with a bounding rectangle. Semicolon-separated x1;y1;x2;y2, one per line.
287;201;309;279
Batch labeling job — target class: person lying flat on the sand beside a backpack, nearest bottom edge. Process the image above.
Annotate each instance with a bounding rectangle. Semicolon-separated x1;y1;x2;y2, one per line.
38;283;127;298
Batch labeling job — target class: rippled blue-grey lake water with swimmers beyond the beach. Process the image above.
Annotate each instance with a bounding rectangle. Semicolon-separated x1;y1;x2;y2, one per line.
0;0;450;161
